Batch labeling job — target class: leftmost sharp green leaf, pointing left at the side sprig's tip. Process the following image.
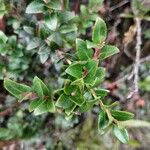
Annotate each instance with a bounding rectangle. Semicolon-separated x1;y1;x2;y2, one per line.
4;78;31;99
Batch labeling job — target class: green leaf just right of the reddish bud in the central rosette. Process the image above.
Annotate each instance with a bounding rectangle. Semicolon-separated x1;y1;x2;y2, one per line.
84;60;98;84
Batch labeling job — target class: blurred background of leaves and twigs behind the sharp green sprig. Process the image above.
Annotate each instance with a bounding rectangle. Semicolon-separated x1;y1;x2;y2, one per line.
0;0;150;150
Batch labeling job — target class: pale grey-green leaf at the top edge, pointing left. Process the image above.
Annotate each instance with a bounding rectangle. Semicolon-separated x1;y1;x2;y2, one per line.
26;1;45;14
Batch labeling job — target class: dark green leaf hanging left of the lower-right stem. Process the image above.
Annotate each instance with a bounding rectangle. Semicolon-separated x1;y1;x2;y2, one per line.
98;110;109;131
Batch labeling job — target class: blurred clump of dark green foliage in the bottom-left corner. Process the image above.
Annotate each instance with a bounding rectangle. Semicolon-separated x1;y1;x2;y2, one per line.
0;110;42;140
